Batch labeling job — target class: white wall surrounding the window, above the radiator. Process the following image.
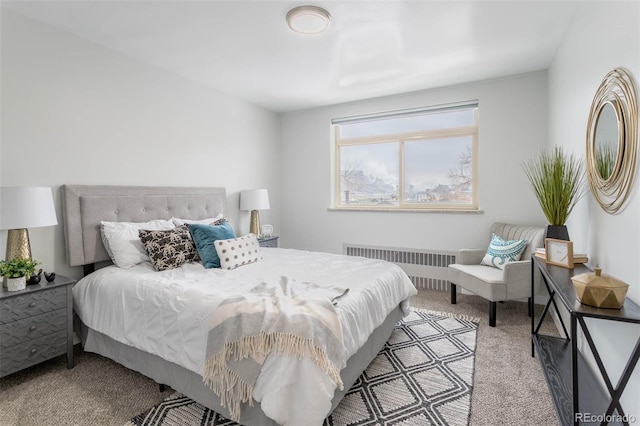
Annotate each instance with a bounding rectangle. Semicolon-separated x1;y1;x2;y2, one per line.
281;72;547;253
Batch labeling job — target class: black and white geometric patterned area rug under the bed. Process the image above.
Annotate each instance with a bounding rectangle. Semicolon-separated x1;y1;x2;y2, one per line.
125;309;478;426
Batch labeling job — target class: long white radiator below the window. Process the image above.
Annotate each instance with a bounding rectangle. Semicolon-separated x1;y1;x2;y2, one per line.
342;243;456;291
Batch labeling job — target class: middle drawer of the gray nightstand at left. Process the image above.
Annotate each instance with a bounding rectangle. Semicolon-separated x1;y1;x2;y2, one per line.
0;309;67;348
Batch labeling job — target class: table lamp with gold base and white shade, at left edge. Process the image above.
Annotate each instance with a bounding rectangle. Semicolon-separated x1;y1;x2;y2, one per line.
0;186;58;260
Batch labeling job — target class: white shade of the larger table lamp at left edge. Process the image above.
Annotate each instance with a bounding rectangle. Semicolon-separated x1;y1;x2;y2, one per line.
0;186;58;229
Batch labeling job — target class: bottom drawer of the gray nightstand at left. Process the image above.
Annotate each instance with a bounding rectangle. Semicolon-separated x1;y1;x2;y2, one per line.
0;330;67;377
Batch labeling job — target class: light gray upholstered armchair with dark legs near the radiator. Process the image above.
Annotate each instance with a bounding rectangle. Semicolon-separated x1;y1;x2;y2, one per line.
447;223;545;327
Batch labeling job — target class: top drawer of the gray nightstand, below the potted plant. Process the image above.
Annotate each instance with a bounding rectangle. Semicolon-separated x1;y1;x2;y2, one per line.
0;286;67;324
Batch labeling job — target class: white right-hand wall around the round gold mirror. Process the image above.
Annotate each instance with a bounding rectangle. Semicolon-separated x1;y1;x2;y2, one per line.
549;1;640;419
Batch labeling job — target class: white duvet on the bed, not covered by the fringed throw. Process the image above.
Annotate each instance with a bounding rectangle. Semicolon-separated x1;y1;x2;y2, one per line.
73;248;416;426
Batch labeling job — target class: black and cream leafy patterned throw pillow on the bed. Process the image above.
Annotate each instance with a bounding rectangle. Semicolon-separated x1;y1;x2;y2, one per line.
138;225;200;271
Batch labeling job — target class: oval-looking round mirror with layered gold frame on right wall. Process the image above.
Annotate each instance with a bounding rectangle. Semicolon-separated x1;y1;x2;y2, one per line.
587;68;638;213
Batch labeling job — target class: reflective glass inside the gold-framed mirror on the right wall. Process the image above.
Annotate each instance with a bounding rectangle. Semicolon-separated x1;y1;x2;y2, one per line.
595;102;620;181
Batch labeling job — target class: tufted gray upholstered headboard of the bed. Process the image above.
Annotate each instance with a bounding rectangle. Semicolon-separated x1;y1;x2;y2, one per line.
61;185;227;266
